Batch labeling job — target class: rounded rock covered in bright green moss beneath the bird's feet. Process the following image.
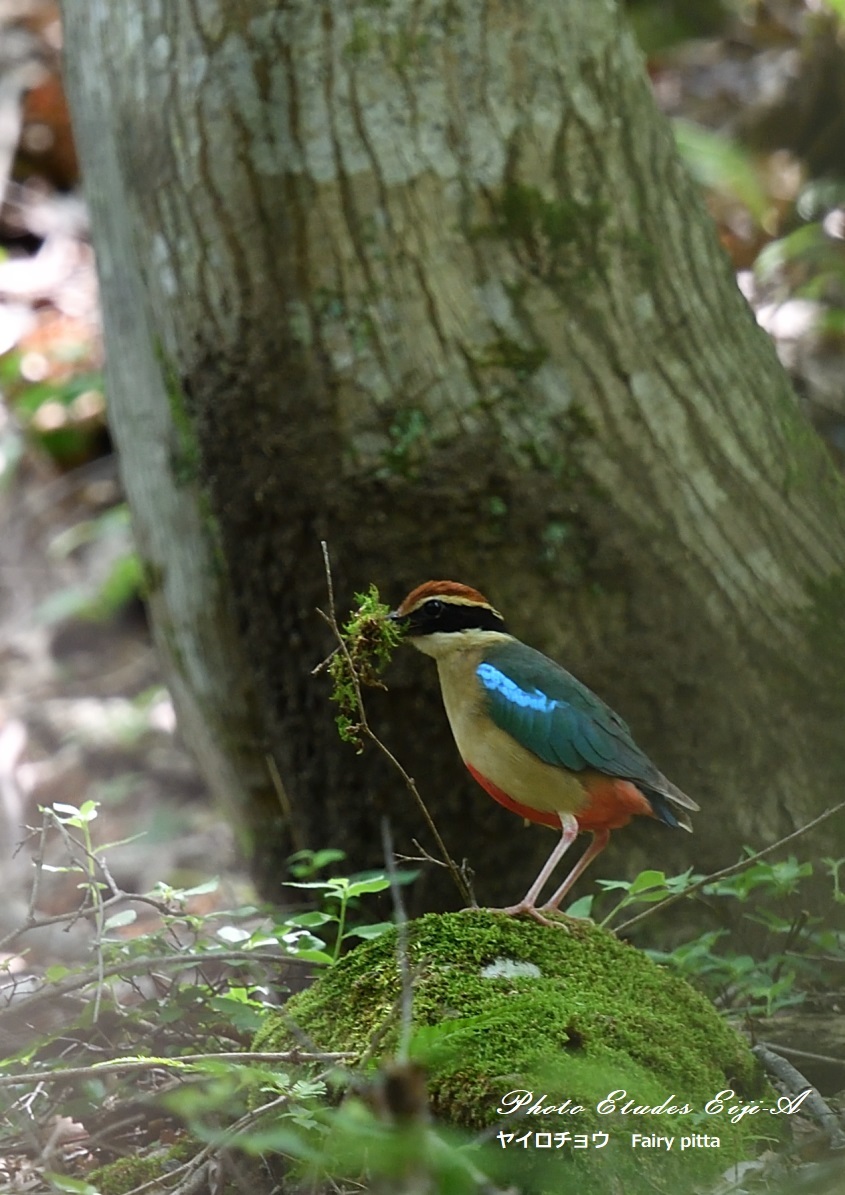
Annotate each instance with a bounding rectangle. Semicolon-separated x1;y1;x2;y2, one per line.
255;909;778;1193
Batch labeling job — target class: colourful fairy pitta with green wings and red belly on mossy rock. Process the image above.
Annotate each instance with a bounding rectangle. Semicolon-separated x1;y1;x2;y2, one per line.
391;581;698;924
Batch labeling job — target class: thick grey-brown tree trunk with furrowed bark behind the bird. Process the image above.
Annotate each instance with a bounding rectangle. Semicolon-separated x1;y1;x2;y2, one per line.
65;0;845;903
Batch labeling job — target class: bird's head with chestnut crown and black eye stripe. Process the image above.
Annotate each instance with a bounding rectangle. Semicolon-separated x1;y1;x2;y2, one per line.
390;581;508;657
